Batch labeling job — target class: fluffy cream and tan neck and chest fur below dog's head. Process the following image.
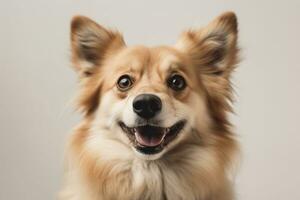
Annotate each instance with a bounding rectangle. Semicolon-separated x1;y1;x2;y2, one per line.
62;127;231;200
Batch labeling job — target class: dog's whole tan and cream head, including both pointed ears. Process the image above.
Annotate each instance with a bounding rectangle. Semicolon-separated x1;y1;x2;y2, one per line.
71;13;237;159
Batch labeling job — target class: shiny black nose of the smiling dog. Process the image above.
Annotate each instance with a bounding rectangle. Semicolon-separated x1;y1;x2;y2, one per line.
132;94;162;119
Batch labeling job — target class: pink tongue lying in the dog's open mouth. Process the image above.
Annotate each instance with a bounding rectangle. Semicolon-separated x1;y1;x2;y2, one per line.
135;131;165;147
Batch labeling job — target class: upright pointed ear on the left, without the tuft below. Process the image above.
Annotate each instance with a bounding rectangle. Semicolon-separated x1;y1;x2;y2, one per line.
71;16;125;76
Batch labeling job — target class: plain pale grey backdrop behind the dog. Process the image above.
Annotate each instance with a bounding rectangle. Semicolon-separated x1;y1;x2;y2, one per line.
0;0;300;200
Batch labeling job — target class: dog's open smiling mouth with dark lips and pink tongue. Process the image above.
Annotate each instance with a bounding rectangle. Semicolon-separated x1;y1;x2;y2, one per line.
119;120;186;154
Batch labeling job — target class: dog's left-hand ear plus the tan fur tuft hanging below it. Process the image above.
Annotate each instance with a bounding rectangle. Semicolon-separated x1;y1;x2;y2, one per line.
71;16;125;115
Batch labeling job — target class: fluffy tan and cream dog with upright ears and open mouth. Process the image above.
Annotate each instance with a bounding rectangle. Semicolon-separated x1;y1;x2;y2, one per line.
59;12;239;200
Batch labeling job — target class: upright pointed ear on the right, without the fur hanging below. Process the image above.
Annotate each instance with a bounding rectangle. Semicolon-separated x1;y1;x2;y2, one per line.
176;12;238;75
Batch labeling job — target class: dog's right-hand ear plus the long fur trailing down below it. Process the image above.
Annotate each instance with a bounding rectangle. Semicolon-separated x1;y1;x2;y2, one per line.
176;12;238;126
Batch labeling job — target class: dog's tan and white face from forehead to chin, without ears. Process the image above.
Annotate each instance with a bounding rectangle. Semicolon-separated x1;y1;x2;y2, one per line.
97;47;207;159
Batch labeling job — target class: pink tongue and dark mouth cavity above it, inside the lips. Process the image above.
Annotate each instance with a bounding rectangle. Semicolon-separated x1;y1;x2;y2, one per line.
135;126;166;147
